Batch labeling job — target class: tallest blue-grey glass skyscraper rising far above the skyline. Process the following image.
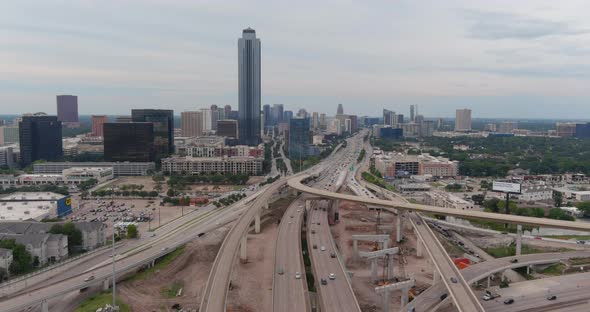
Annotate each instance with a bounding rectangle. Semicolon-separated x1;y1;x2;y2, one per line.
238;28;261;145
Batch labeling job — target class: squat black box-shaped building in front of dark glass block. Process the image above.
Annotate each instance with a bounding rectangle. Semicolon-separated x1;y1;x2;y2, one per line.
103;122;157;162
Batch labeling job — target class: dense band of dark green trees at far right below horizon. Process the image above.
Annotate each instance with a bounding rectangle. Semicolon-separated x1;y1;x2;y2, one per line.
424;137;590;177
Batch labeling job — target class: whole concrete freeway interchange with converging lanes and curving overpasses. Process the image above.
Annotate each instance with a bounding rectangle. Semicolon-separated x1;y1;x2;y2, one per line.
5;133;590;312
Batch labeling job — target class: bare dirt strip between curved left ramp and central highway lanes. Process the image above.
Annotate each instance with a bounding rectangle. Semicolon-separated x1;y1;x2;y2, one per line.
227;198;293;312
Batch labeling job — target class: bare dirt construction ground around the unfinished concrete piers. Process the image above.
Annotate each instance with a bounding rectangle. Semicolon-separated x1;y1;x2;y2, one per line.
332;191;432;311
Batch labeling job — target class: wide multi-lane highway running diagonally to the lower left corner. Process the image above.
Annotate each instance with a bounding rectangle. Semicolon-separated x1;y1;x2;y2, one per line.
0;185;268;312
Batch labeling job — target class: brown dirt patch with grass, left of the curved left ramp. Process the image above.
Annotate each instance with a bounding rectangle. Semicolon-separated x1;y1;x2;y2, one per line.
118;227;229;312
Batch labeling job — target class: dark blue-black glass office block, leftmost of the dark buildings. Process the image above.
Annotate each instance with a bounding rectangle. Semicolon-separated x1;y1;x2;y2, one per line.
19;115;63;167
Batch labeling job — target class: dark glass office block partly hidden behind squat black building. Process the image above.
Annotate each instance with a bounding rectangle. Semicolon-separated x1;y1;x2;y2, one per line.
131;109;174;159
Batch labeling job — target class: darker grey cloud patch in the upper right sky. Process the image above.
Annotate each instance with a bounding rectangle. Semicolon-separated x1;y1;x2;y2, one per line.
466;10;588;40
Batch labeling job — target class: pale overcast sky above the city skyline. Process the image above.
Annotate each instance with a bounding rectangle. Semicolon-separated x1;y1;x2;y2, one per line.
0;0;590;119
